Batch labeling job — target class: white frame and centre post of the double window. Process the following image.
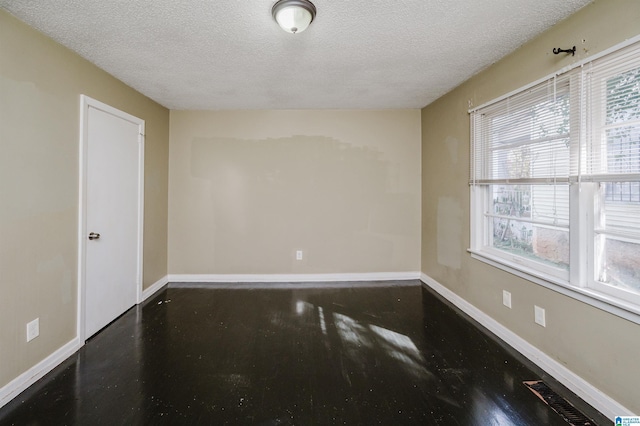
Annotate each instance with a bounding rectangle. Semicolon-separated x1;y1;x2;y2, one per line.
468;35;640;324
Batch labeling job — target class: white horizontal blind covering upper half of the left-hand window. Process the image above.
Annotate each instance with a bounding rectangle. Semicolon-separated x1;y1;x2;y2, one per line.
471;76;570;185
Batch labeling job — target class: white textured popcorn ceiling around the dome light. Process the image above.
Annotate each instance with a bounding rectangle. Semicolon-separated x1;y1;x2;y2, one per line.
0;0;590;109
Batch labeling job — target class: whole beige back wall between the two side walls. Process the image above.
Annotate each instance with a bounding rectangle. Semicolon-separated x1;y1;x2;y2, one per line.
169;110;420;274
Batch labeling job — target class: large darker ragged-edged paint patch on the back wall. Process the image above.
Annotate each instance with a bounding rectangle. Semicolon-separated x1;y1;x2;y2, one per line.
182;135;420;273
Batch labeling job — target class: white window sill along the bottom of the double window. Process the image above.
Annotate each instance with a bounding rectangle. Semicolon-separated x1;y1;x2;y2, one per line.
467;249;640;324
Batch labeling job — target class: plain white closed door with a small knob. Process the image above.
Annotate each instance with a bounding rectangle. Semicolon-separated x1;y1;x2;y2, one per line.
81;97;144;339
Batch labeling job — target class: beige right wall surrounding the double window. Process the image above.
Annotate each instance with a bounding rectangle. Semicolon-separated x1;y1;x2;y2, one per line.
422;0;640;413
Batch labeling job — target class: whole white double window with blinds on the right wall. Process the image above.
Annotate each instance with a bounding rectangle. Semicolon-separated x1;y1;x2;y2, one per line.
470;42;640;313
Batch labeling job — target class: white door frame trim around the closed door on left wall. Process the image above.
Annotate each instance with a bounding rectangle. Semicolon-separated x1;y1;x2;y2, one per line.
76;95;145;345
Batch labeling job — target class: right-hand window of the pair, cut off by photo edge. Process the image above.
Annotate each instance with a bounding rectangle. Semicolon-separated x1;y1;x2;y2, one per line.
582;47;640;300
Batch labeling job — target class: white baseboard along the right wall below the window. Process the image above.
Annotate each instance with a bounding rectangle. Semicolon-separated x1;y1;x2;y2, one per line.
420;273;633;419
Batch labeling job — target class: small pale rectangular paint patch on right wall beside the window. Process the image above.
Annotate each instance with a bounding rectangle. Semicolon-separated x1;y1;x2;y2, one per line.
437;197;463;269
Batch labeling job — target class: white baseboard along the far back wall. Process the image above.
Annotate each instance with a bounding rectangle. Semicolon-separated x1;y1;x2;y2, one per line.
168;272;420;283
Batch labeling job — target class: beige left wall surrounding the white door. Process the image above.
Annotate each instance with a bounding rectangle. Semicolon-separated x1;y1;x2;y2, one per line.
0;10;169;387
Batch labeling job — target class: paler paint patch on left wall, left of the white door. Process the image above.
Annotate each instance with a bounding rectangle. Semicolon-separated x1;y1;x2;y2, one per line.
0;77;78;226
